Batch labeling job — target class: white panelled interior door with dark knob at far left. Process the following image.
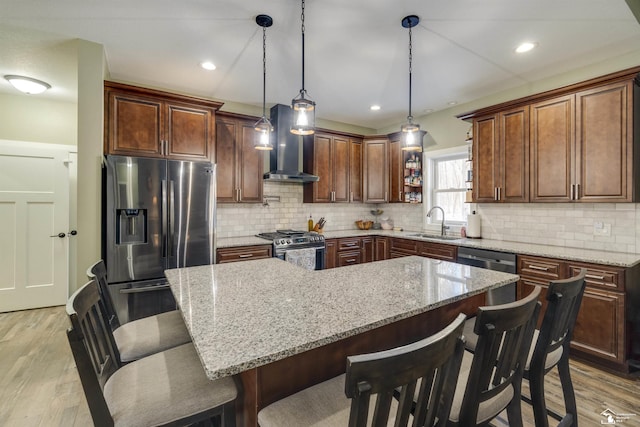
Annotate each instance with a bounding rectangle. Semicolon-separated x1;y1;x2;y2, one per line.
0;141;74;312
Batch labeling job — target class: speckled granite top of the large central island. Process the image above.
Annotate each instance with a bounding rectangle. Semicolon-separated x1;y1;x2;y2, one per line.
166;256;518;379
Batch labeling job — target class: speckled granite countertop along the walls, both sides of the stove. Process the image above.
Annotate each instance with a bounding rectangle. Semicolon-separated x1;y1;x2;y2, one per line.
217;229;640;268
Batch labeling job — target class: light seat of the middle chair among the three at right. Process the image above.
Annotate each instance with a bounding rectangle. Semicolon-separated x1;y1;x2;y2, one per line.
449;338;514;424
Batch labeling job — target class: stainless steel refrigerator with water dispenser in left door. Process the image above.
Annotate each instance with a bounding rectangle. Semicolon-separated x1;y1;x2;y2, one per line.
103;156;216;323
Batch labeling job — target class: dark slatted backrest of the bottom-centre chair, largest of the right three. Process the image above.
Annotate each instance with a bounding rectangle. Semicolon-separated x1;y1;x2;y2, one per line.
345;314;466;427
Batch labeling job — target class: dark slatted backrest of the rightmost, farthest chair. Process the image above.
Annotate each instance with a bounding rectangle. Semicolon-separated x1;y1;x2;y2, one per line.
529;269;587;372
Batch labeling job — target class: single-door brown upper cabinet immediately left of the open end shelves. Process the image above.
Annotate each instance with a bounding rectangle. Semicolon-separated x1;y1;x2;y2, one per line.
363;137;389;203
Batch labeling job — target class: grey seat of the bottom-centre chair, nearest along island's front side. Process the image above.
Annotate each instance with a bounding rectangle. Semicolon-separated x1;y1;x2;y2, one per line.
258;374;397;427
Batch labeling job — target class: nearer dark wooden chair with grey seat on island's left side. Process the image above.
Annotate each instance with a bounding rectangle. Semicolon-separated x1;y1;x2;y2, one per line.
67;280;238;427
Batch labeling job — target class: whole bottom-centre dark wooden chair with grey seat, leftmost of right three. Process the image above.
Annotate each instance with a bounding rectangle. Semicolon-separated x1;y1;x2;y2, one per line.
258;314;465;427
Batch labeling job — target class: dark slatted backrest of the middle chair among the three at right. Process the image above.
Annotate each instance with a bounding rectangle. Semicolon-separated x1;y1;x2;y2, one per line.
458;286;541;426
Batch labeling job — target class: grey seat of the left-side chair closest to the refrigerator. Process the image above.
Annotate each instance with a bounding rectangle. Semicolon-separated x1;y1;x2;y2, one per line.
113;310;191;363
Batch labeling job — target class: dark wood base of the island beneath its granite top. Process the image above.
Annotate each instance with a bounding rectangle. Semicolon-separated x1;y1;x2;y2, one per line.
237;294;485;427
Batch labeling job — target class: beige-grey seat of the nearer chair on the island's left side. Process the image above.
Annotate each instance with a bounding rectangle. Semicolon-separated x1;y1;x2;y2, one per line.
103;343;237;427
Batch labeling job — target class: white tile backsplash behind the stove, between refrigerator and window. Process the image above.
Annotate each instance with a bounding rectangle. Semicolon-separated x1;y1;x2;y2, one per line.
217;181;424;238
